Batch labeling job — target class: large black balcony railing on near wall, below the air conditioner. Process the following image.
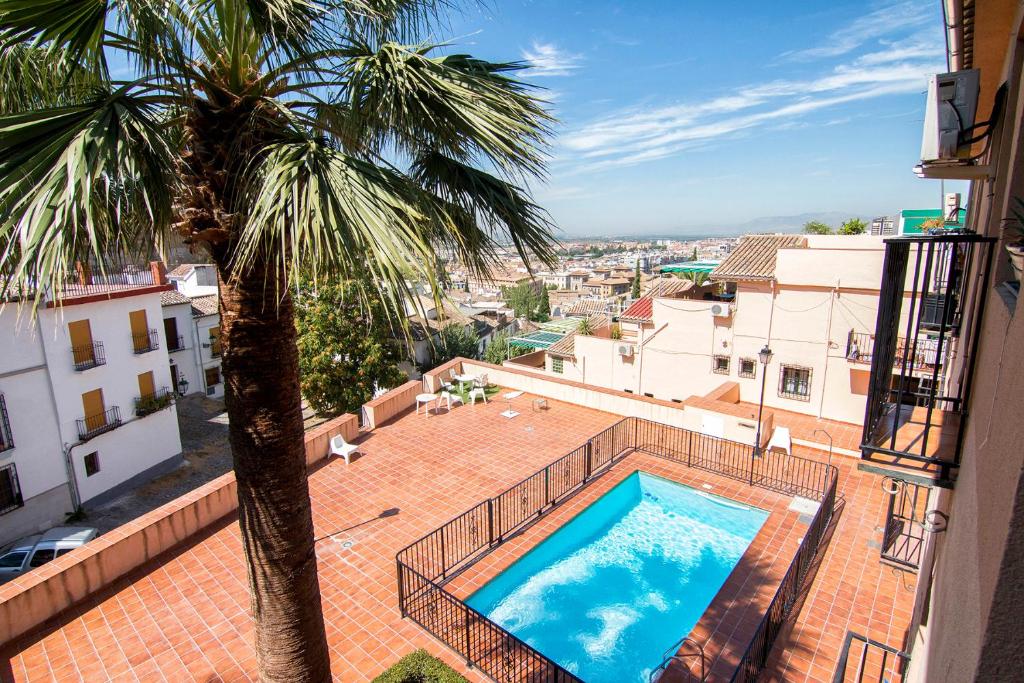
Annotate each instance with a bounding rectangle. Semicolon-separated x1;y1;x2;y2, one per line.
860;233;995;481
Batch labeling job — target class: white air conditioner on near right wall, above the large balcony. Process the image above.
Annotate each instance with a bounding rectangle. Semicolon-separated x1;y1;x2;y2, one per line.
921;69;980;163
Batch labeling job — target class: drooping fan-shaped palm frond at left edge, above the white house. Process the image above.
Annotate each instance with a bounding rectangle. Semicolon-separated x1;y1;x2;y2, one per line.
0;88;175;300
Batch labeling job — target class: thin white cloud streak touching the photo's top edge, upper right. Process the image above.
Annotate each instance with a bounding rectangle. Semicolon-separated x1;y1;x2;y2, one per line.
780;0;935;61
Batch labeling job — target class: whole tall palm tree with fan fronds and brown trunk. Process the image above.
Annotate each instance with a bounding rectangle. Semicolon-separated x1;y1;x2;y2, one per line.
0;0;555;681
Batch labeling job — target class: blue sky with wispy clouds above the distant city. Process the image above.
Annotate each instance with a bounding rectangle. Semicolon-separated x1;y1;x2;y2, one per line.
437;0;963;236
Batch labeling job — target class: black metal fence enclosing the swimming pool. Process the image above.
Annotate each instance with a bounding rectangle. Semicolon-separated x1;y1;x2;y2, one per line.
395;418;838;683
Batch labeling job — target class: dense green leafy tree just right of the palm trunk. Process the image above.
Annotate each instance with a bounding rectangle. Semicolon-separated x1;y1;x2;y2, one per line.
295;281;406;415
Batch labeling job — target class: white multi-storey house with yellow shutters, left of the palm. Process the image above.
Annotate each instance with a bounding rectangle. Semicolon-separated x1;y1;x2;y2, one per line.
0;264;181;540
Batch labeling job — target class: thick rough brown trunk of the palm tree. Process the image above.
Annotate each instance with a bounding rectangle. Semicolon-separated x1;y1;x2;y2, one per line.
218;259;331;681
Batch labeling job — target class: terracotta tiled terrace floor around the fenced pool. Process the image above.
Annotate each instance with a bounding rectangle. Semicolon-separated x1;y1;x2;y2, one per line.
0;394;913;682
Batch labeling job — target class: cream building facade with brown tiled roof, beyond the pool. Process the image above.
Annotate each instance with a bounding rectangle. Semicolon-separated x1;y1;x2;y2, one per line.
546;236;924;423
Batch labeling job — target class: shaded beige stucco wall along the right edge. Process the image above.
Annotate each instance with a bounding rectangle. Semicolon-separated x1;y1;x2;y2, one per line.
907;13;1024;682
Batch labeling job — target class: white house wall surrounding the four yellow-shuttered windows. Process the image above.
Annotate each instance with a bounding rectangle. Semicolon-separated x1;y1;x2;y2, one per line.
40;293;181;501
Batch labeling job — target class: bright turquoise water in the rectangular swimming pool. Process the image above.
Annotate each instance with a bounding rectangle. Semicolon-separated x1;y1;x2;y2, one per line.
467;472;768;683
